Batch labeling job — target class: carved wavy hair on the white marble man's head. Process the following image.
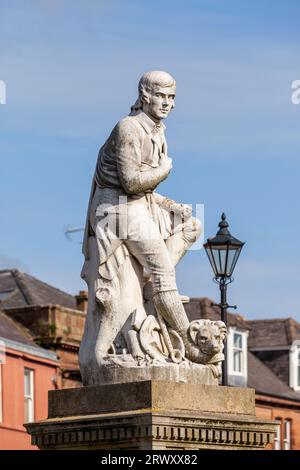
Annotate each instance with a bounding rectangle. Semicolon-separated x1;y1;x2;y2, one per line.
130;70;176;114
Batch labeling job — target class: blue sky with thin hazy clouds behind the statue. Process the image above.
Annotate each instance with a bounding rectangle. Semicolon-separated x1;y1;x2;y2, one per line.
0;0;300;321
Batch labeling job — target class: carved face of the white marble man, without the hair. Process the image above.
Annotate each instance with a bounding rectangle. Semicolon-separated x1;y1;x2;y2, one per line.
143;86;175;121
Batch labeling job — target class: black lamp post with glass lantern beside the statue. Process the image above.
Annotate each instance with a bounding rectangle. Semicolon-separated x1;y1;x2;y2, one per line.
204;212;244;385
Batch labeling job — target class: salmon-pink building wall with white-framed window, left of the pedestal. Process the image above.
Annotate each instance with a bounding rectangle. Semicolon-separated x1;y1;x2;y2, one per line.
0;338;58;450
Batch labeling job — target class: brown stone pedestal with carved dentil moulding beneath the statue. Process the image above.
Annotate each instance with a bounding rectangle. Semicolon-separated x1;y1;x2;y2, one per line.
26;381;275;450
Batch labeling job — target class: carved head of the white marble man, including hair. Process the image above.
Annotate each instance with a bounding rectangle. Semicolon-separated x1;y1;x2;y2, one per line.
131;71;176;121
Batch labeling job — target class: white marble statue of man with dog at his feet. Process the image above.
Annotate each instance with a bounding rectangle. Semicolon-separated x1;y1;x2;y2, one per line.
79;71;226;385
